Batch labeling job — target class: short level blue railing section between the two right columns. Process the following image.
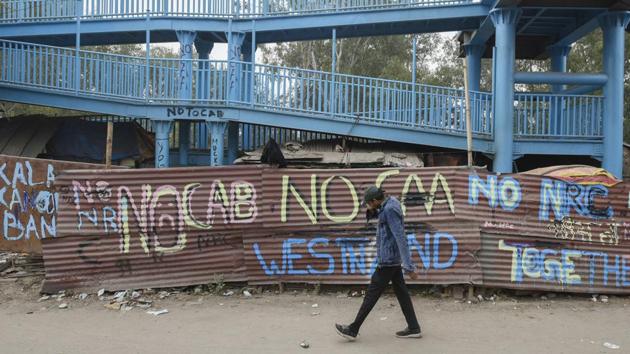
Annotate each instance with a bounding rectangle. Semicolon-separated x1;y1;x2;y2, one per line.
514;93;604;138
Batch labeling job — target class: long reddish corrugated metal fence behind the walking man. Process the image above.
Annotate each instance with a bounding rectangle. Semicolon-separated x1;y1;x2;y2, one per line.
44;167;630;293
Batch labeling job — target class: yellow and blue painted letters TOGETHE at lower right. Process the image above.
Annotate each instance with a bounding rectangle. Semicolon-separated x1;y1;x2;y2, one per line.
499;240;630;287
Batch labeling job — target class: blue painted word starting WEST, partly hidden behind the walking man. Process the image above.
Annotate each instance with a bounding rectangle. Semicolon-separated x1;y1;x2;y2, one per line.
252;232;458;276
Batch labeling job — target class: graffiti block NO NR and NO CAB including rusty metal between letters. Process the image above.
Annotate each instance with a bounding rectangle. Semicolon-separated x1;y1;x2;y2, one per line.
64;179;258;254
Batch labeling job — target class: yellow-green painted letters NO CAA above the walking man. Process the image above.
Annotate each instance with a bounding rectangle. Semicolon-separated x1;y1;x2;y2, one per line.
280;170;455;225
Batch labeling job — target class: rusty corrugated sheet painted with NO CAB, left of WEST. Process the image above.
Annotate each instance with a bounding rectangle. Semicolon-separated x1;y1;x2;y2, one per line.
44;167;262;290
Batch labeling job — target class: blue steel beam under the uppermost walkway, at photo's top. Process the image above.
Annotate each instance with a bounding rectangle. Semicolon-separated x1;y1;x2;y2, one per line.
0;4;489;46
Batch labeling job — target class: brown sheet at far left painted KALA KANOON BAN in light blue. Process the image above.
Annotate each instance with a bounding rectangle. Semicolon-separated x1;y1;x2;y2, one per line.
0;155;111;254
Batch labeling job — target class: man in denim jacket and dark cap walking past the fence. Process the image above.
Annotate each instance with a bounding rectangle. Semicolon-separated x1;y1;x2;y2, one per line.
335;186;421;341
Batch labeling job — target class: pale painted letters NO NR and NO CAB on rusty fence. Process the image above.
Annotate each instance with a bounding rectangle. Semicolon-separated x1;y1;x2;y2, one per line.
73;180;258;254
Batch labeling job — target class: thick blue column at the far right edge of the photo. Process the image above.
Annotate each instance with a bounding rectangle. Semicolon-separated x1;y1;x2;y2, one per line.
600;12;630;178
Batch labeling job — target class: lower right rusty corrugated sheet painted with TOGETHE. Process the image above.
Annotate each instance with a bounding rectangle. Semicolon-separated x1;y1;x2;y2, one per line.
480;234;630;294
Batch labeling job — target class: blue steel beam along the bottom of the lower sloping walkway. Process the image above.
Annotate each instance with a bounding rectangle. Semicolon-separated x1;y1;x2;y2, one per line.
0;86;602;157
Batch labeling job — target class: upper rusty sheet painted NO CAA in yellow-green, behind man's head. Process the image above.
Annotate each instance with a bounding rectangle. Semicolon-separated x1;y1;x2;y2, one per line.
262;168;468;230
